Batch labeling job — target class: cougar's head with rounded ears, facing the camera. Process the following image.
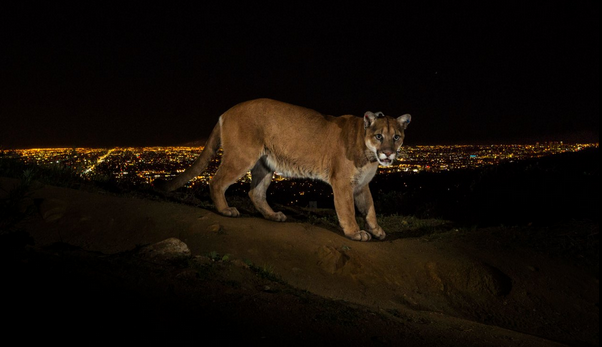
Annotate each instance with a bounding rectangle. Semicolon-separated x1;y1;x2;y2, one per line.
364;111;412;166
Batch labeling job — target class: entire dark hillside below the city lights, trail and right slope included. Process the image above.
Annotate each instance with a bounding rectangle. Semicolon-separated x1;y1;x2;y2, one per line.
0;150;599;346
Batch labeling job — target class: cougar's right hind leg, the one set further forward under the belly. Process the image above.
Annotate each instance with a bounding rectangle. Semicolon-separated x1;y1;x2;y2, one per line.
249;156;286;222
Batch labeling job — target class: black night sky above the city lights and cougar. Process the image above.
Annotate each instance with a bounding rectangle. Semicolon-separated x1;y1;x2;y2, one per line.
0;1;600;149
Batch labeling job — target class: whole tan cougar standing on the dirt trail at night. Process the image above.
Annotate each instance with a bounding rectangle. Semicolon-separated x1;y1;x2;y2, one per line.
156;99;410;241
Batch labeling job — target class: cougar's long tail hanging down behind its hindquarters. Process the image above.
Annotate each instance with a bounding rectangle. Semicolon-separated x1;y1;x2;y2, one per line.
153;123;221;192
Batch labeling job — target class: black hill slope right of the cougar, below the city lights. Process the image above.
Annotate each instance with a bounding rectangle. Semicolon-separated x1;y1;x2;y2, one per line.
371;149;600;226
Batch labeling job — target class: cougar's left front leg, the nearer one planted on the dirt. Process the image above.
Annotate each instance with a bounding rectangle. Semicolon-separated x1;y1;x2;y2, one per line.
332;182;372;241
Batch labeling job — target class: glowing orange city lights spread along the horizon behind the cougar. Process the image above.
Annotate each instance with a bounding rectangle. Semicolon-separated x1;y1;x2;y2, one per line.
0;142;599;187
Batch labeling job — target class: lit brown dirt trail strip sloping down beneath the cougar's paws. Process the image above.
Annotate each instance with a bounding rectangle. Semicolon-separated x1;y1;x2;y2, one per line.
0;179;599;345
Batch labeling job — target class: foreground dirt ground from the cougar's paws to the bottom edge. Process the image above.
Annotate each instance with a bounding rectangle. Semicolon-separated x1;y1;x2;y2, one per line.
0;178;599;346
